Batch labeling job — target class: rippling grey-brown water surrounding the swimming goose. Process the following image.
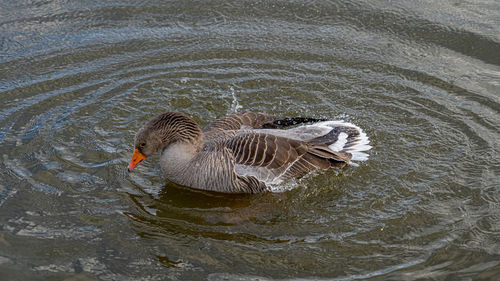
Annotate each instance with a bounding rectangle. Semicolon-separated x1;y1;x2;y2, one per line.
0;0;500;280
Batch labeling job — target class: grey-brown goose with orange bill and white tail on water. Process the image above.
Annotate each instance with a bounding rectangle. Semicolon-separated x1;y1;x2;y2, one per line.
128;112;371;193
